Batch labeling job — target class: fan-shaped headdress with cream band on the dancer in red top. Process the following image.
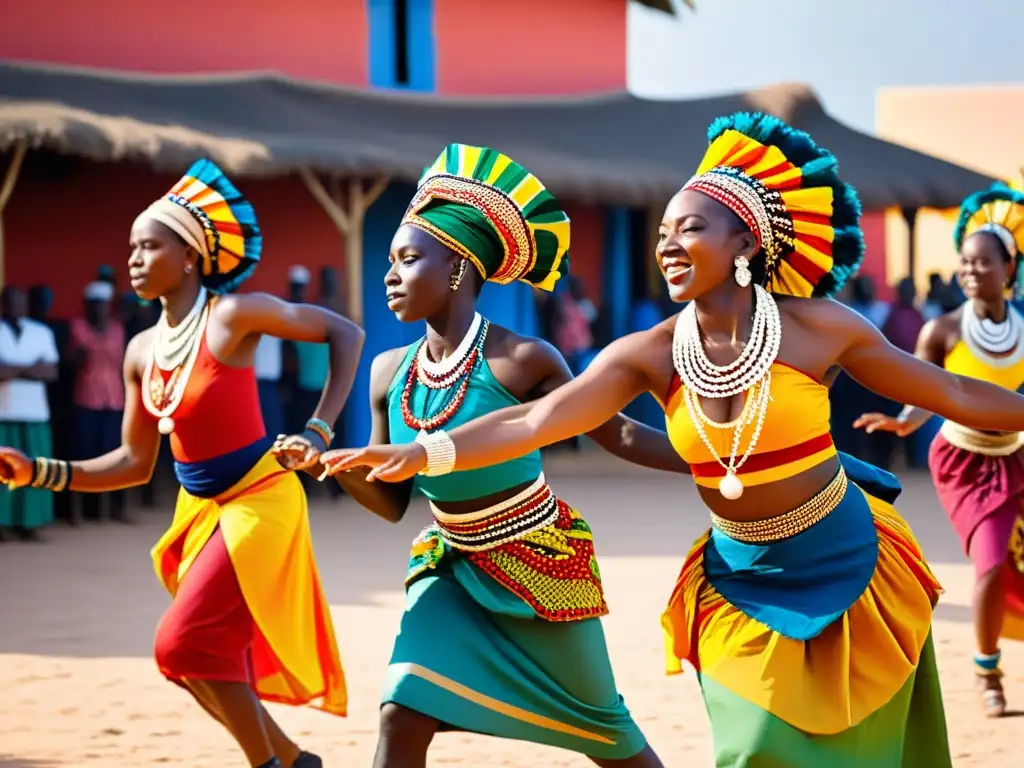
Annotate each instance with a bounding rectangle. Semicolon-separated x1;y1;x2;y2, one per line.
140;160;263;293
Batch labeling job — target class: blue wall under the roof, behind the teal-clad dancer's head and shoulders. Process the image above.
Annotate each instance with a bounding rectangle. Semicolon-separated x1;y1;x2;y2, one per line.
341;183;537;445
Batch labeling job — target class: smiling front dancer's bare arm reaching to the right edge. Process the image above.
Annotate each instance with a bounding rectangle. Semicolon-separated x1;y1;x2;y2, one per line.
827;302;1024;432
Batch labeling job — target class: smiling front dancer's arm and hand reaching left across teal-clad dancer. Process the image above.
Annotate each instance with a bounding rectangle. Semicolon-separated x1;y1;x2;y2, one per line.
319;331;667;482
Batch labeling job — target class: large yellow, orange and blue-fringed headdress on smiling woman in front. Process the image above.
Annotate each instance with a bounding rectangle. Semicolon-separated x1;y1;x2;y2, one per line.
684;113;864;297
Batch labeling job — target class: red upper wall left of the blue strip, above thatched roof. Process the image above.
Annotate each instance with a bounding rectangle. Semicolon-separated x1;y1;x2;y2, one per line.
0;0;368;85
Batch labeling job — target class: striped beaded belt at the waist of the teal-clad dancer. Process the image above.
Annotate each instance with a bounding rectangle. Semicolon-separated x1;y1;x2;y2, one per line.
430;472;558;552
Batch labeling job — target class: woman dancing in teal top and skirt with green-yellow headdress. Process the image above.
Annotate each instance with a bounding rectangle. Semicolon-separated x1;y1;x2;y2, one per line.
315;144;686;768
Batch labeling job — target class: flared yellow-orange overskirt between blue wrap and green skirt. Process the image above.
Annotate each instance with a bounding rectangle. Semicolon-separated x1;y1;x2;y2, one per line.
662;496;941;735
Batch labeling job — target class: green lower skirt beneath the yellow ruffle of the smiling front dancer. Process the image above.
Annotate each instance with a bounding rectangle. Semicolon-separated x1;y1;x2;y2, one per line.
700;636;952;768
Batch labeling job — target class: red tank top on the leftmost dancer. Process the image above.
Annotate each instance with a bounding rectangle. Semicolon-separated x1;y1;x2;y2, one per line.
149;333;266;464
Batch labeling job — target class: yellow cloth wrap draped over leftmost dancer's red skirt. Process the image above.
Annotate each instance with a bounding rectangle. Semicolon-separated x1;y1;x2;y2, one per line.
152;454;347;715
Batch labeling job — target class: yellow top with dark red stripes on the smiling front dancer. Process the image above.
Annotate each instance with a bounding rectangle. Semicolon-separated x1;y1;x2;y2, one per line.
665;362;836;487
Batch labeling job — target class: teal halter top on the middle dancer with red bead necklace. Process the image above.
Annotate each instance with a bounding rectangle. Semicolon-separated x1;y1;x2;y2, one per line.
387;342;542;502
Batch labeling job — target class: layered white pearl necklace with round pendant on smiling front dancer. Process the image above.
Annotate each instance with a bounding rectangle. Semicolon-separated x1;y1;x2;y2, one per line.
672;285;782;499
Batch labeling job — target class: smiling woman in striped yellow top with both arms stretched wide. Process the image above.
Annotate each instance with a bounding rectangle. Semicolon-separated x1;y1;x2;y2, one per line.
322;114;1024;768
